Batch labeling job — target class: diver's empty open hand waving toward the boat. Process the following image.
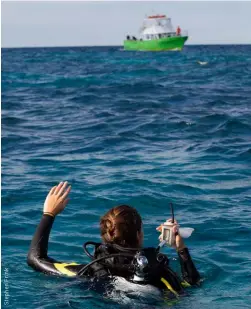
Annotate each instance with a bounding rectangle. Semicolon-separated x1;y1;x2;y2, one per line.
44;181;71;216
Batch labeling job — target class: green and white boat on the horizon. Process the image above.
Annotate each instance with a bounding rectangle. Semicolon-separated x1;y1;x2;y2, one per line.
124;15;188;51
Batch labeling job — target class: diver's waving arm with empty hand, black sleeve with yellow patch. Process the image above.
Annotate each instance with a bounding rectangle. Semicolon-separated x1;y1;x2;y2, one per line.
27;182;83;277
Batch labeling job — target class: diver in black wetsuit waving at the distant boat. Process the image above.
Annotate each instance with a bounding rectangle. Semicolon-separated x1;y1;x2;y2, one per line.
27;182;200;297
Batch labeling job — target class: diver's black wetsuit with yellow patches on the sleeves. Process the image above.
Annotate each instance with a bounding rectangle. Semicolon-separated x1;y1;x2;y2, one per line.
27;214;200;294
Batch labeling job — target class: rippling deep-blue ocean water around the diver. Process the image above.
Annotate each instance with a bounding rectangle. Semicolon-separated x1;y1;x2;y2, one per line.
2;46;251;309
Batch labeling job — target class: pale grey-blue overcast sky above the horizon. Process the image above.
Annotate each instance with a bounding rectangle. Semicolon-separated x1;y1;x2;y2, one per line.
2;1;251;47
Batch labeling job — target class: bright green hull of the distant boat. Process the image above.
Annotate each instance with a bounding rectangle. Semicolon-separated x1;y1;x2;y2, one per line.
124;36;188;51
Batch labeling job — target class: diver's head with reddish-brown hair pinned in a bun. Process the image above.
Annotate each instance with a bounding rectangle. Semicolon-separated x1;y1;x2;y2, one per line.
100;205;143;248
